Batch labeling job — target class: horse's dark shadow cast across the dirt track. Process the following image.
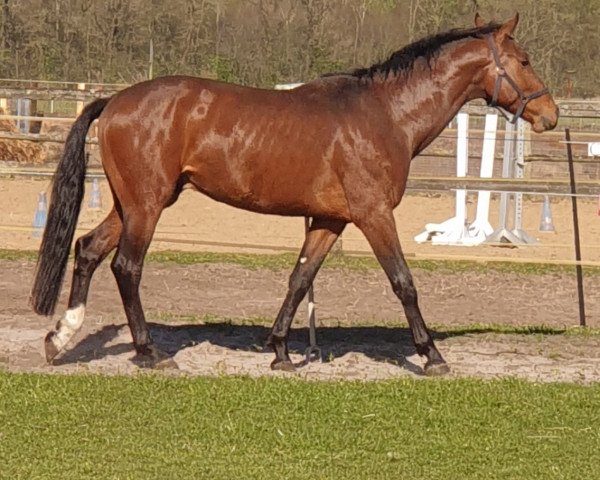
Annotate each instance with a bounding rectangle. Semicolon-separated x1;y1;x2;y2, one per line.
53;323;560;375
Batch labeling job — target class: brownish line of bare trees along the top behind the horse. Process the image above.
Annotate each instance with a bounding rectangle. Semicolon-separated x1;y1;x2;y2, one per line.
0;0;600;97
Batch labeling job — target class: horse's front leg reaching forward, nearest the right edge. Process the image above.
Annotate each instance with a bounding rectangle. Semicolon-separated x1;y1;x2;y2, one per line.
355;208;450;376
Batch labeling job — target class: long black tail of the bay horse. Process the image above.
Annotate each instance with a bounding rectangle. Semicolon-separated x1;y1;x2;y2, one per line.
31;98;109;315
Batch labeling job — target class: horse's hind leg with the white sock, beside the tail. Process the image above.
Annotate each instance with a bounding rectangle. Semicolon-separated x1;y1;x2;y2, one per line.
44;209;122;363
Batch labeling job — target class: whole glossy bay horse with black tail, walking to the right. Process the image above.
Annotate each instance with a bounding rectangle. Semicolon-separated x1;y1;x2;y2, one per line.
31;15;558;375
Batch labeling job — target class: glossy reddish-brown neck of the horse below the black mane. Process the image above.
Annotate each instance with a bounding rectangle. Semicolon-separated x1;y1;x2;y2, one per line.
384;39;489;158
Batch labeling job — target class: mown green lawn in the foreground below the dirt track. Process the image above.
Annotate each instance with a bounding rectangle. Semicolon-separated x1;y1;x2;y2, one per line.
0;373;600;480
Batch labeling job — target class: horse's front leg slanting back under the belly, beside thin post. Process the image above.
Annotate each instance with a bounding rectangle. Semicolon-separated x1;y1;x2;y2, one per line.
267;218;346;371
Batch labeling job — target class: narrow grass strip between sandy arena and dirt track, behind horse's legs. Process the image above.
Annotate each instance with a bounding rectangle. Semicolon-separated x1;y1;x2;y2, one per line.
0;249;600;276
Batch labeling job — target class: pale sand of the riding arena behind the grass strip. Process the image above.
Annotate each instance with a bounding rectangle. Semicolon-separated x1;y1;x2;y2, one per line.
0;178;600;265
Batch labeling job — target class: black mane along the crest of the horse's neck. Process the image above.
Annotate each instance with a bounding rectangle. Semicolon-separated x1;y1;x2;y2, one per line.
348;23;500;79
